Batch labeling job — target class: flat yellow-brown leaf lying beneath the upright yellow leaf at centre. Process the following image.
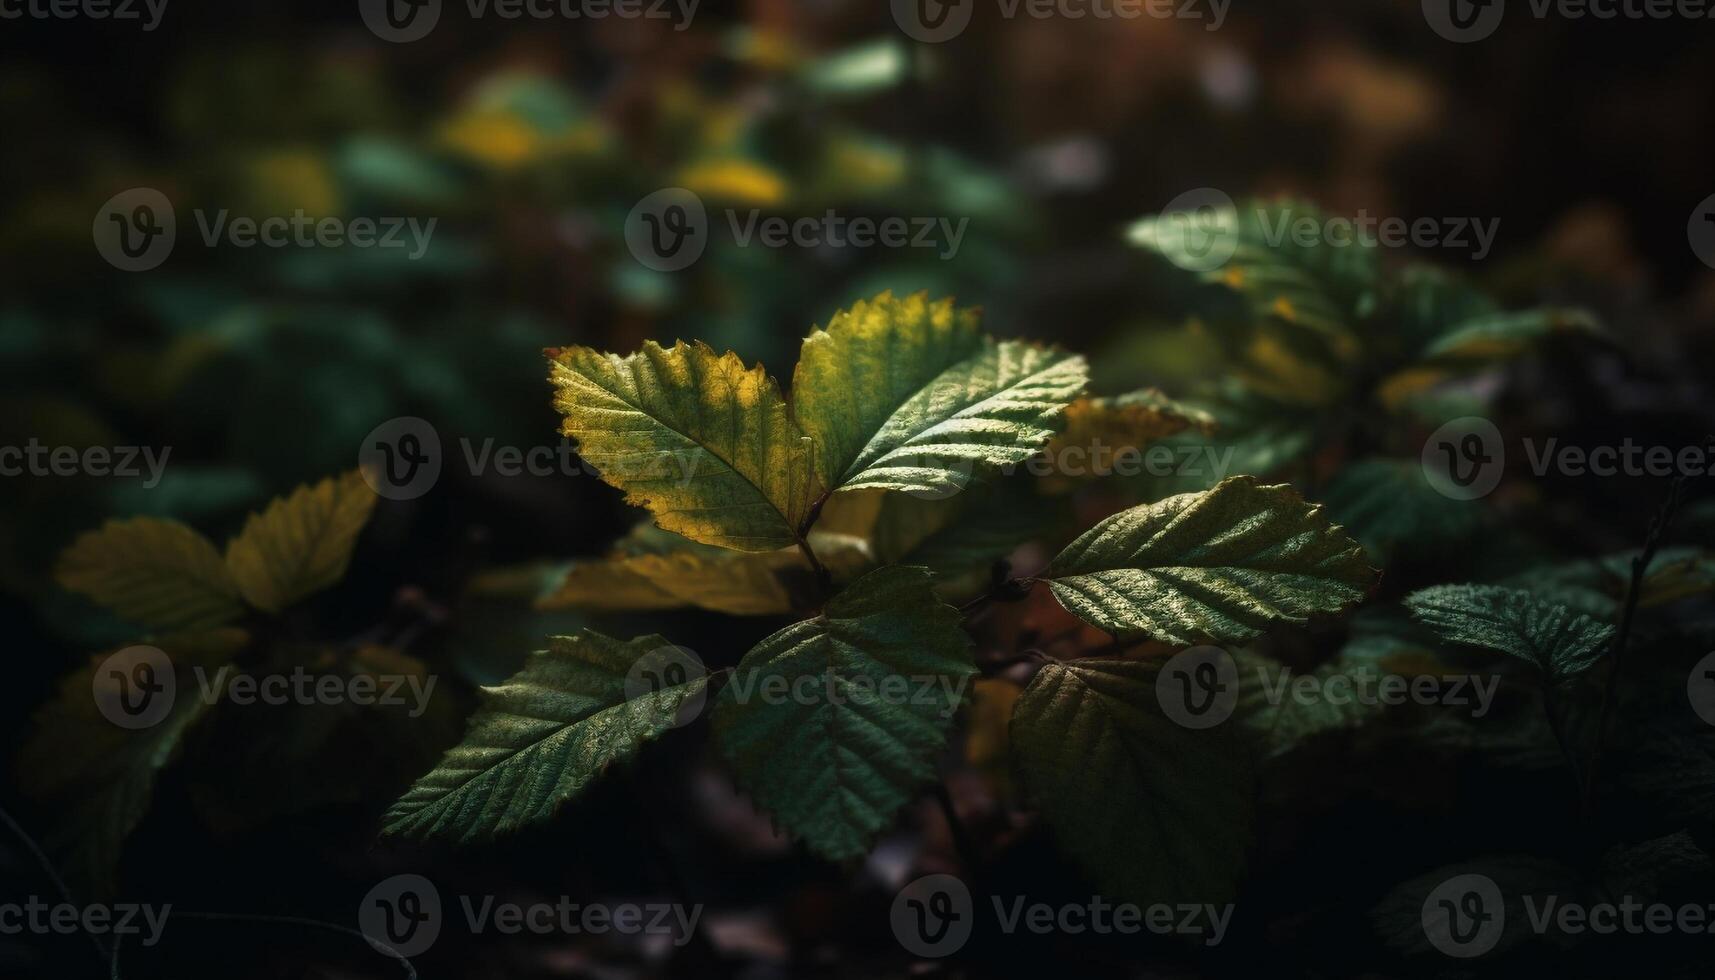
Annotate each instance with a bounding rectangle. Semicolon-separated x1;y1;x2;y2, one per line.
537;525;873;616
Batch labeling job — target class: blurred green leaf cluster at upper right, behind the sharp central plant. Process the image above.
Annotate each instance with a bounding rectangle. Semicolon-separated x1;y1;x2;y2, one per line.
1115;199;1602;560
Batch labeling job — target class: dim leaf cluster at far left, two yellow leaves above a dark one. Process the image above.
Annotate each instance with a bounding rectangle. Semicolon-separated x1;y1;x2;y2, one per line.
21;472;392;891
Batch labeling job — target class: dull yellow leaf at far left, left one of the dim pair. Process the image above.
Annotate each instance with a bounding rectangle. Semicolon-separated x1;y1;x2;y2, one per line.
55;517;244;630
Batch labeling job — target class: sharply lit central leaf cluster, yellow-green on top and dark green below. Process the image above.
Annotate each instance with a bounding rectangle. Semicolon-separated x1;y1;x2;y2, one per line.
386;293;1377;901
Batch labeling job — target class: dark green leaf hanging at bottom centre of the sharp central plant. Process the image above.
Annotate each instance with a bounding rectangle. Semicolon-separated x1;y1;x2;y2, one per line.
713;565;976;860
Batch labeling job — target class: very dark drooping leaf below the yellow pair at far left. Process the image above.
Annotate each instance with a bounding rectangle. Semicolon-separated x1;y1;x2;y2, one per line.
19;628;249;894
